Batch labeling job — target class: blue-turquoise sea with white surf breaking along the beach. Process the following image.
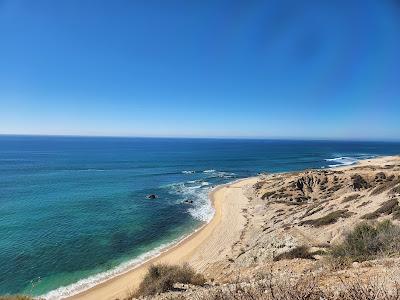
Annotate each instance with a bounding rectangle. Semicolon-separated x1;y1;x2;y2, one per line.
0;136;400;298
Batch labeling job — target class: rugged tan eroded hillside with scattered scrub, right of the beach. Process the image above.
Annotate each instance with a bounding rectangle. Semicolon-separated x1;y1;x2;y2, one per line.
232;157;400;266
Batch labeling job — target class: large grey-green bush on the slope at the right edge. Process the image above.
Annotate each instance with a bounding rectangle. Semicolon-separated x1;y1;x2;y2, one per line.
331;220;400;262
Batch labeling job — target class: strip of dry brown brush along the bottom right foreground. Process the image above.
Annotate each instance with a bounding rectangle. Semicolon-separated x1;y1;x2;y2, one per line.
157;274;400;300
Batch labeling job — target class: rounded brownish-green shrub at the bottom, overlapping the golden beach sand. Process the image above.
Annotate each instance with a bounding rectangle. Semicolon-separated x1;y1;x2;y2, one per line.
135;264;205;296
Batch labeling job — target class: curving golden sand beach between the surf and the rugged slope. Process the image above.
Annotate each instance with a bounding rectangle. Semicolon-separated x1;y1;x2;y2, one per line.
68;177;258;300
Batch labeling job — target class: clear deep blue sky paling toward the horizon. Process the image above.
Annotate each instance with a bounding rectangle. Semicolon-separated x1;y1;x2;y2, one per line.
0;0;400;139
